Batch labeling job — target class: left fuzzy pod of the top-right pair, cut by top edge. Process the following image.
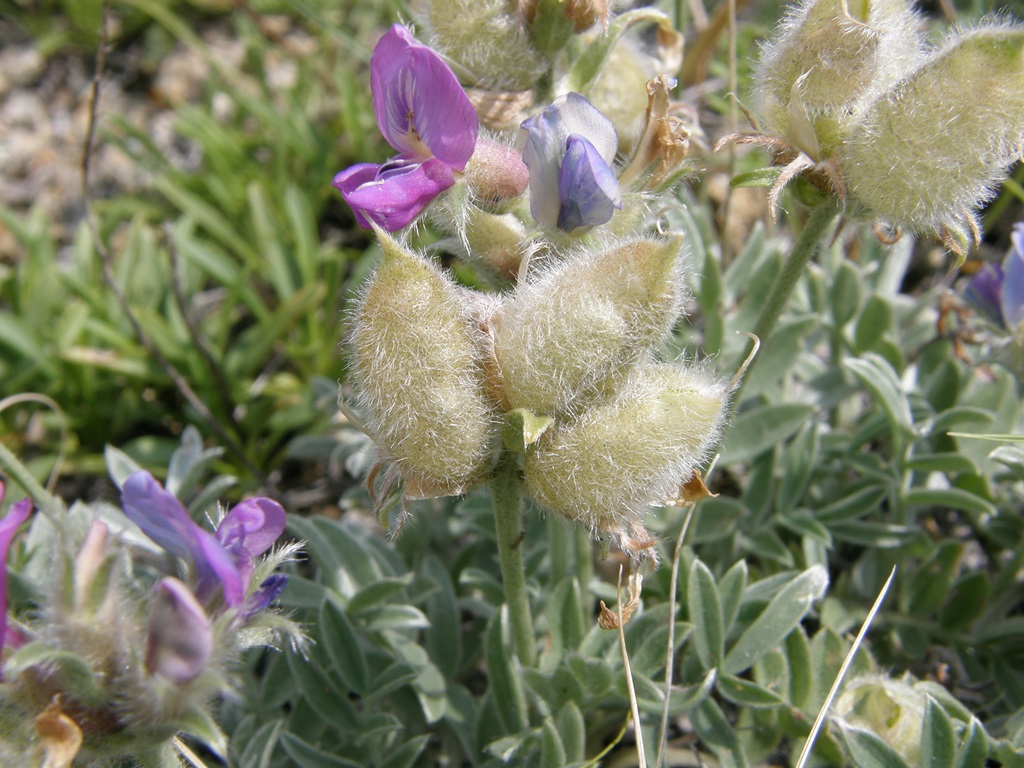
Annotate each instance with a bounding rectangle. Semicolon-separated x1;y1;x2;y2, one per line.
755;0;923;160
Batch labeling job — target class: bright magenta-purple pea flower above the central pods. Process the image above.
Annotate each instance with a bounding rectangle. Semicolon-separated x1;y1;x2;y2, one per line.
333;25;479;231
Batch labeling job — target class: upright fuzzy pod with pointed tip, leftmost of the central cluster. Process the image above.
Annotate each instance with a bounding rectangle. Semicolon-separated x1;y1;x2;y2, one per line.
349;228;497;499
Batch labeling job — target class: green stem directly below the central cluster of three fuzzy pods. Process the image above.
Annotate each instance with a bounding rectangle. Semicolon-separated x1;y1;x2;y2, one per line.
490;451;537;667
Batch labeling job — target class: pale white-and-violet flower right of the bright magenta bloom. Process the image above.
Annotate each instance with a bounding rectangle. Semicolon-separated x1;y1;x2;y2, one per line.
522;93;623;231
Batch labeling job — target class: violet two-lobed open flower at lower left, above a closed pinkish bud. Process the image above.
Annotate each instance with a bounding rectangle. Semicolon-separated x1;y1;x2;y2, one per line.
121;471;285;607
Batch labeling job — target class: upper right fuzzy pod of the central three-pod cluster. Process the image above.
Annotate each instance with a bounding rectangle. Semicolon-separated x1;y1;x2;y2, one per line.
490;238;686;415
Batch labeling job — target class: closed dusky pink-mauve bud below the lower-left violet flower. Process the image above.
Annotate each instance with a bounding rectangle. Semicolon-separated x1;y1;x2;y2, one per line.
145;579;213;685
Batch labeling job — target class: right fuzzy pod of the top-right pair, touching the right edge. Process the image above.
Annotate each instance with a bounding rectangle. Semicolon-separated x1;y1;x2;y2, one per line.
837;23;1024;252
